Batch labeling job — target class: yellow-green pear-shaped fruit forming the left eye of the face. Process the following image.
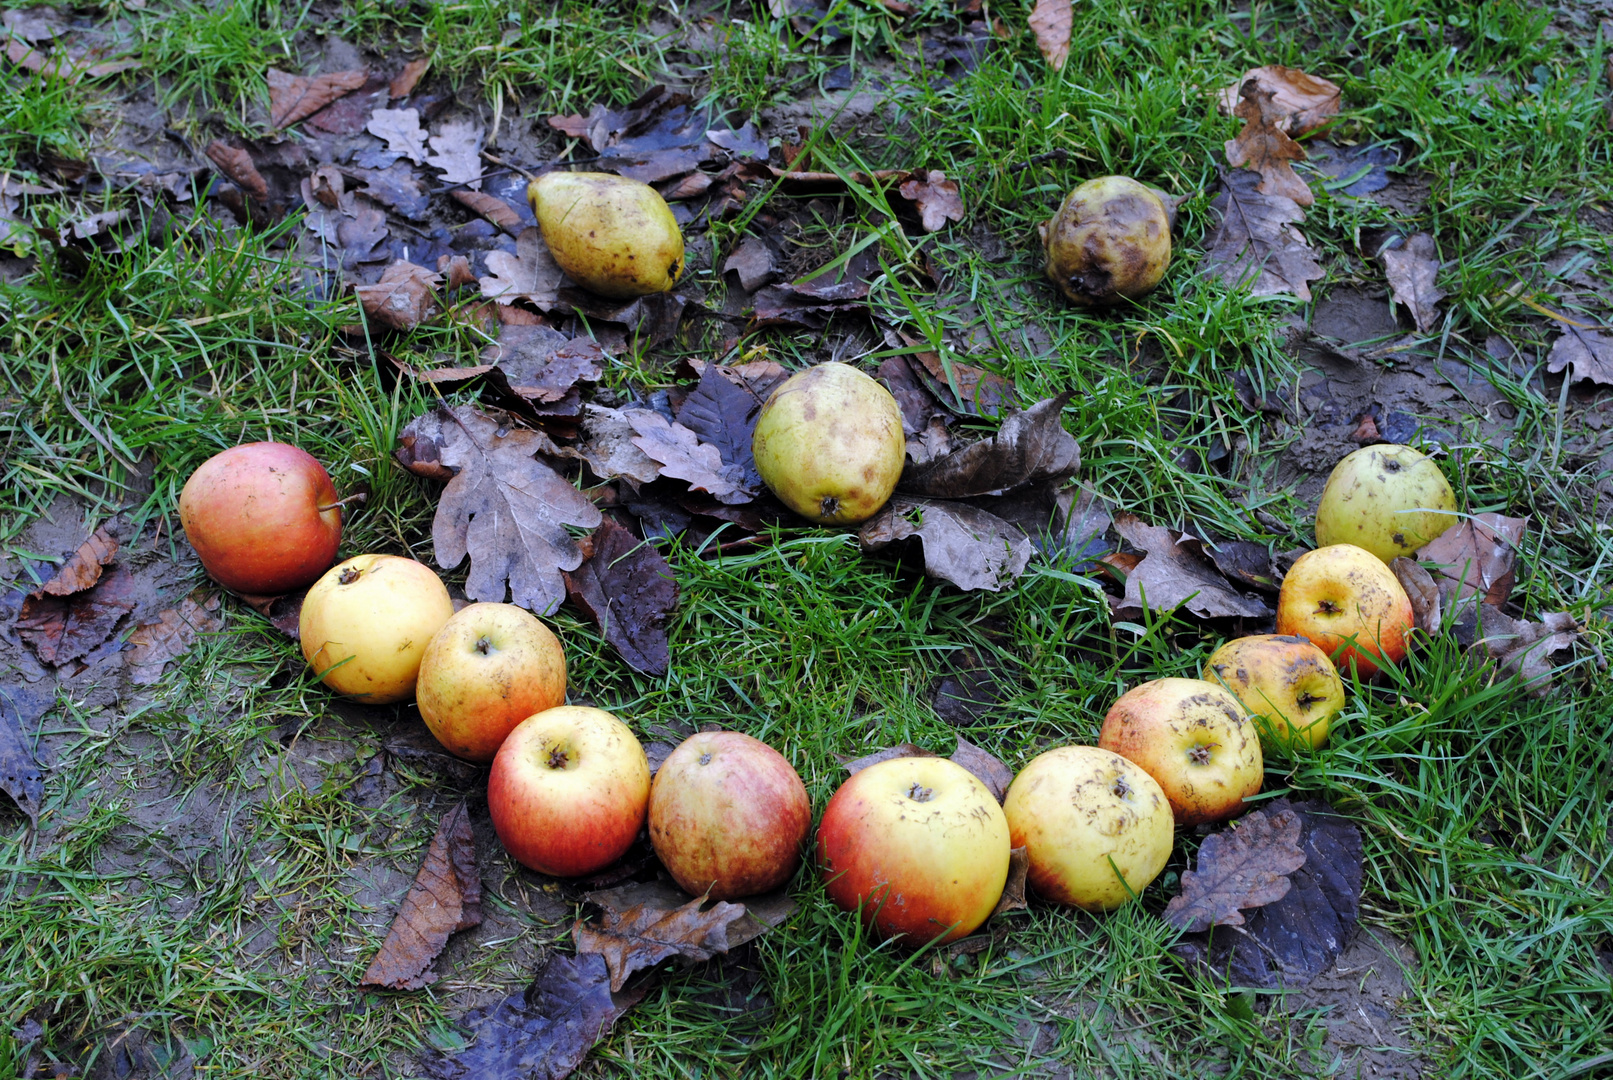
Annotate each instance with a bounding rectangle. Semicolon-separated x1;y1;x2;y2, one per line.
526;172;684;298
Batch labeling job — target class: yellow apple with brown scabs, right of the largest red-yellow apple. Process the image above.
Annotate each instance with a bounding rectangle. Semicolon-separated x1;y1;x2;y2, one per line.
1003;746;1176;911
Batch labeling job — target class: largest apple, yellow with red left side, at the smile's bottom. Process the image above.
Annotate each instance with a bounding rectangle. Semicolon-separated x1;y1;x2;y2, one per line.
818;758;1008;946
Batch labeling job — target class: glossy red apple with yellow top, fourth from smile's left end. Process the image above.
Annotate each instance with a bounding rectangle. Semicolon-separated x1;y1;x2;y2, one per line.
487;704;650;877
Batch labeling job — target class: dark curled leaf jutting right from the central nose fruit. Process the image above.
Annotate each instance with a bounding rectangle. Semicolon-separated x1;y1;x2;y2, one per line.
898;392;1081;498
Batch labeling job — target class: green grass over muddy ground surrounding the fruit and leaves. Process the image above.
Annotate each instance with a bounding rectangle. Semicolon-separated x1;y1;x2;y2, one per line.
0;0;1613;1080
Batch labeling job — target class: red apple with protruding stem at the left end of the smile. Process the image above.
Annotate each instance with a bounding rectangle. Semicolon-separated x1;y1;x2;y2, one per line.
179;443;342;596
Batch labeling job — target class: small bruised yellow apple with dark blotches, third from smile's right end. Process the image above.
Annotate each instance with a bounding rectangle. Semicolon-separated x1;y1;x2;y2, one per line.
1203;633;1344;750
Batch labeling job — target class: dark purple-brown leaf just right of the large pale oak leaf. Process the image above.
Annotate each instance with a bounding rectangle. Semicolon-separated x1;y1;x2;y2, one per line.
566;517;677;675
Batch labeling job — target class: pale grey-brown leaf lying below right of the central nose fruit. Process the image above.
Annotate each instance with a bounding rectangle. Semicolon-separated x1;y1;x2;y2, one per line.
858;495;1036;592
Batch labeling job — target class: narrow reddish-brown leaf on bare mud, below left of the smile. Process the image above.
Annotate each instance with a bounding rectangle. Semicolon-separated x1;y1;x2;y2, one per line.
358;803;482;990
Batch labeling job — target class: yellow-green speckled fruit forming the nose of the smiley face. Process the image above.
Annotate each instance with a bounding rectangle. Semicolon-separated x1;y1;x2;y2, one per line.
750;361;907;525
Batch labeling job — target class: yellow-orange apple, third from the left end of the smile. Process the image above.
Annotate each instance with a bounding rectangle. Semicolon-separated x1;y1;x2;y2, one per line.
415;604;566;761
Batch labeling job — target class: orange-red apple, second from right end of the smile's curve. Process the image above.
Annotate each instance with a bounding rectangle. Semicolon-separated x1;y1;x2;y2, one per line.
1277;543;1413;679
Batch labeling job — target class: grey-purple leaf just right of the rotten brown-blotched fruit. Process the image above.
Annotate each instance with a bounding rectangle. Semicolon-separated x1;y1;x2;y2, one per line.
1203;169;1323;300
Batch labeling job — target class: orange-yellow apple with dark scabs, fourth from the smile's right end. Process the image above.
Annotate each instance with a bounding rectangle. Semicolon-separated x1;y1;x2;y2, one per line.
1098;679;1265;825
